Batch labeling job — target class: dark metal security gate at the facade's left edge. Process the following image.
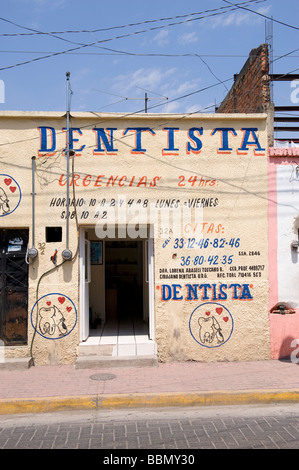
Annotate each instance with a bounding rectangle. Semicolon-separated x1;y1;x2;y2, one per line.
0;230;28;346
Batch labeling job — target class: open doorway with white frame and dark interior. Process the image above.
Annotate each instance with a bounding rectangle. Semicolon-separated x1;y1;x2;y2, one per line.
80;228;154;350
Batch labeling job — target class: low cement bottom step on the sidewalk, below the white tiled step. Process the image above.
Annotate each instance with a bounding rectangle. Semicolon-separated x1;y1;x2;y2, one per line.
75;354;158;370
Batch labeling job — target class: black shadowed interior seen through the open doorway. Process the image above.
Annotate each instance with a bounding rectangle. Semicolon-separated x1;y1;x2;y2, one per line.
105;240;143;321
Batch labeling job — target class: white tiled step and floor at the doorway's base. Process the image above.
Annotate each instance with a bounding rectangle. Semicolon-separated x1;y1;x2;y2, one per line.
80;320;157;356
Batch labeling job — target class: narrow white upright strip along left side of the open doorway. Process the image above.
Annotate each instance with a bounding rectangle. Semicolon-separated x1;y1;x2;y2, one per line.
80;229;91;341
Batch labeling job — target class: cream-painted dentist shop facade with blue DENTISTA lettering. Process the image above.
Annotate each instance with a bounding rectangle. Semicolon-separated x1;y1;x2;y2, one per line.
0;112;271;365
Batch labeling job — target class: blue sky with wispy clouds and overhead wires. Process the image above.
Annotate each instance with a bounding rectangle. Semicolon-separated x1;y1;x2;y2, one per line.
0;0;299;117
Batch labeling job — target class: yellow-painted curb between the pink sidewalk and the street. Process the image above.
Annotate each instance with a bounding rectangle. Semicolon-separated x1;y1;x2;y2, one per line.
0;389;299;415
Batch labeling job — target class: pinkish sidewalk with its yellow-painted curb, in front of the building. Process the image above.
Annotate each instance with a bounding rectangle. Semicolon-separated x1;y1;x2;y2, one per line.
0;360;299;415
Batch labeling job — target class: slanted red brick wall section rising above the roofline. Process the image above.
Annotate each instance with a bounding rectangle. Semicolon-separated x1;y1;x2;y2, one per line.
216;44;271;113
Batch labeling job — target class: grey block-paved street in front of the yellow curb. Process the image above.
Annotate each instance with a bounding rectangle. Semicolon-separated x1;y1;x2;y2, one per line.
0;403;299;450
